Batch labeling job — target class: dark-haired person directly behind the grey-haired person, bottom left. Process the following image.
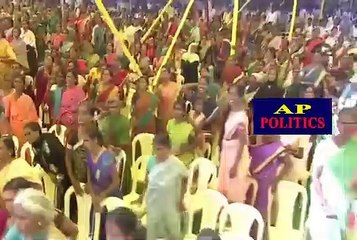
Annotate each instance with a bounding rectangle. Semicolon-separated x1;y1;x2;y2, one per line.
0;177;78;238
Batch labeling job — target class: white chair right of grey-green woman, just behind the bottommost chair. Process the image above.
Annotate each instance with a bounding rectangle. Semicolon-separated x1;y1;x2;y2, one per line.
185;189;228;240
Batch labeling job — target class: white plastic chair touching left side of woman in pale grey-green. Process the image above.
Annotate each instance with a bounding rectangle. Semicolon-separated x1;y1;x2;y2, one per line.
123;156;150;206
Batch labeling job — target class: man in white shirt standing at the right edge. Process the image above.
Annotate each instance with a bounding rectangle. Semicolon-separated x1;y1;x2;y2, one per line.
306;108;357;240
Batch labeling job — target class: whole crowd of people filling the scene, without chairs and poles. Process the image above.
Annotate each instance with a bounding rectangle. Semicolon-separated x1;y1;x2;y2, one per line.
0;1;357;240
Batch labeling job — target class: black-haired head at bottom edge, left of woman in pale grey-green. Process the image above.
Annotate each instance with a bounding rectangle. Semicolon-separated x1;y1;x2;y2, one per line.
107;207;139;236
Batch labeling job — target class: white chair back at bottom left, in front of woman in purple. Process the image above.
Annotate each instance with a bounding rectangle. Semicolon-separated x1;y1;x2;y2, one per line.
64;184;92;240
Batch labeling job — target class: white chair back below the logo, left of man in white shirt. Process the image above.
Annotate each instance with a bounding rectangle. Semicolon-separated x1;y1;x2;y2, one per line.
275;181;307;231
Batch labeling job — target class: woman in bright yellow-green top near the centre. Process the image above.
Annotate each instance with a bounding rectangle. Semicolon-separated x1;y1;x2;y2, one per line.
166;102;196;166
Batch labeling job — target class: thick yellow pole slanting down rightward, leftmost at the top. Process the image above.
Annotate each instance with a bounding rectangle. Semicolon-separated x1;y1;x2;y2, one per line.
95;0;142;76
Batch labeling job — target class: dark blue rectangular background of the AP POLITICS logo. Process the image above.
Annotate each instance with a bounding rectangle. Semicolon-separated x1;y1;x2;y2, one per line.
252;98;332;135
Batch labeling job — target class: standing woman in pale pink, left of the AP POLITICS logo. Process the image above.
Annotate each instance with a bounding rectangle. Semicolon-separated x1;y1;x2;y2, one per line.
218;86;250;202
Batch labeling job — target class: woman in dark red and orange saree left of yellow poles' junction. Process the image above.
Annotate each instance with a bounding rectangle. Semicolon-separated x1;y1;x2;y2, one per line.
94;67;119;109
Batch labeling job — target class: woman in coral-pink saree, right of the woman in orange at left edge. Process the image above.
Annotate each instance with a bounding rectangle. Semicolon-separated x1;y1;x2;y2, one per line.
59;72;85;127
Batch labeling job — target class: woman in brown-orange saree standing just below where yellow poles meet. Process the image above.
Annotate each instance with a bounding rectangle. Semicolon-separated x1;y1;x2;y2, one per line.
132;77;158;136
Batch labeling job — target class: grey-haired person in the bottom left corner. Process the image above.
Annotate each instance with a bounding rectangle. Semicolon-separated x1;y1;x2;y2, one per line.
4;188;66;240
